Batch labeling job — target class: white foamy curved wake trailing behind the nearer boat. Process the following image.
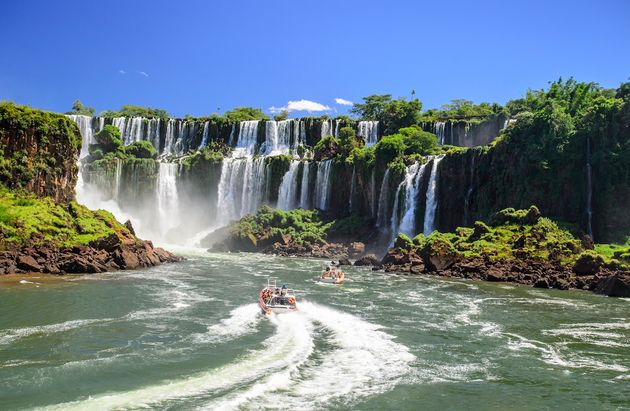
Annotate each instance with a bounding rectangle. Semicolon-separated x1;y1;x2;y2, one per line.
38;301;415;410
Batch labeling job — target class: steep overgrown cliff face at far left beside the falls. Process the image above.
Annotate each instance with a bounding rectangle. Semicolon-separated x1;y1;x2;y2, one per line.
0;103;81;202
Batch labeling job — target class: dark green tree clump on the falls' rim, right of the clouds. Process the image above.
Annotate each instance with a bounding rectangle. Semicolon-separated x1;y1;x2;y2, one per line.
350;94;422;134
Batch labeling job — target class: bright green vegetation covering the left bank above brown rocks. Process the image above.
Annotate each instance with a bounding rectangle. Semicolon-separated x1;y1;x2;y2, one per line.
0;186;129;249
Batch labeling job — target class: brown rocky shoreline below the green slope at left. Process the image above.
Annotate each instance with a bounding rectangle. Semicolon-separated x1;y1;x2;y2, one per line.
0;234;180;275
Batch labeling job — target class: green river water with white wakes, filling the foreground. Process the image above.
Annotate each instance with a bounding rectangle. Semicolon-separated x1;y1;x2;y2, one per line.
0;250;630;410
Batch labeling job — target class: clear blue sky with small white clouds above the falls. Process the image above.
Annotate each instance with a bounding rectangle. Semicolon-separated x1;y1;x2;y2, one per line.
0;0;630;117
